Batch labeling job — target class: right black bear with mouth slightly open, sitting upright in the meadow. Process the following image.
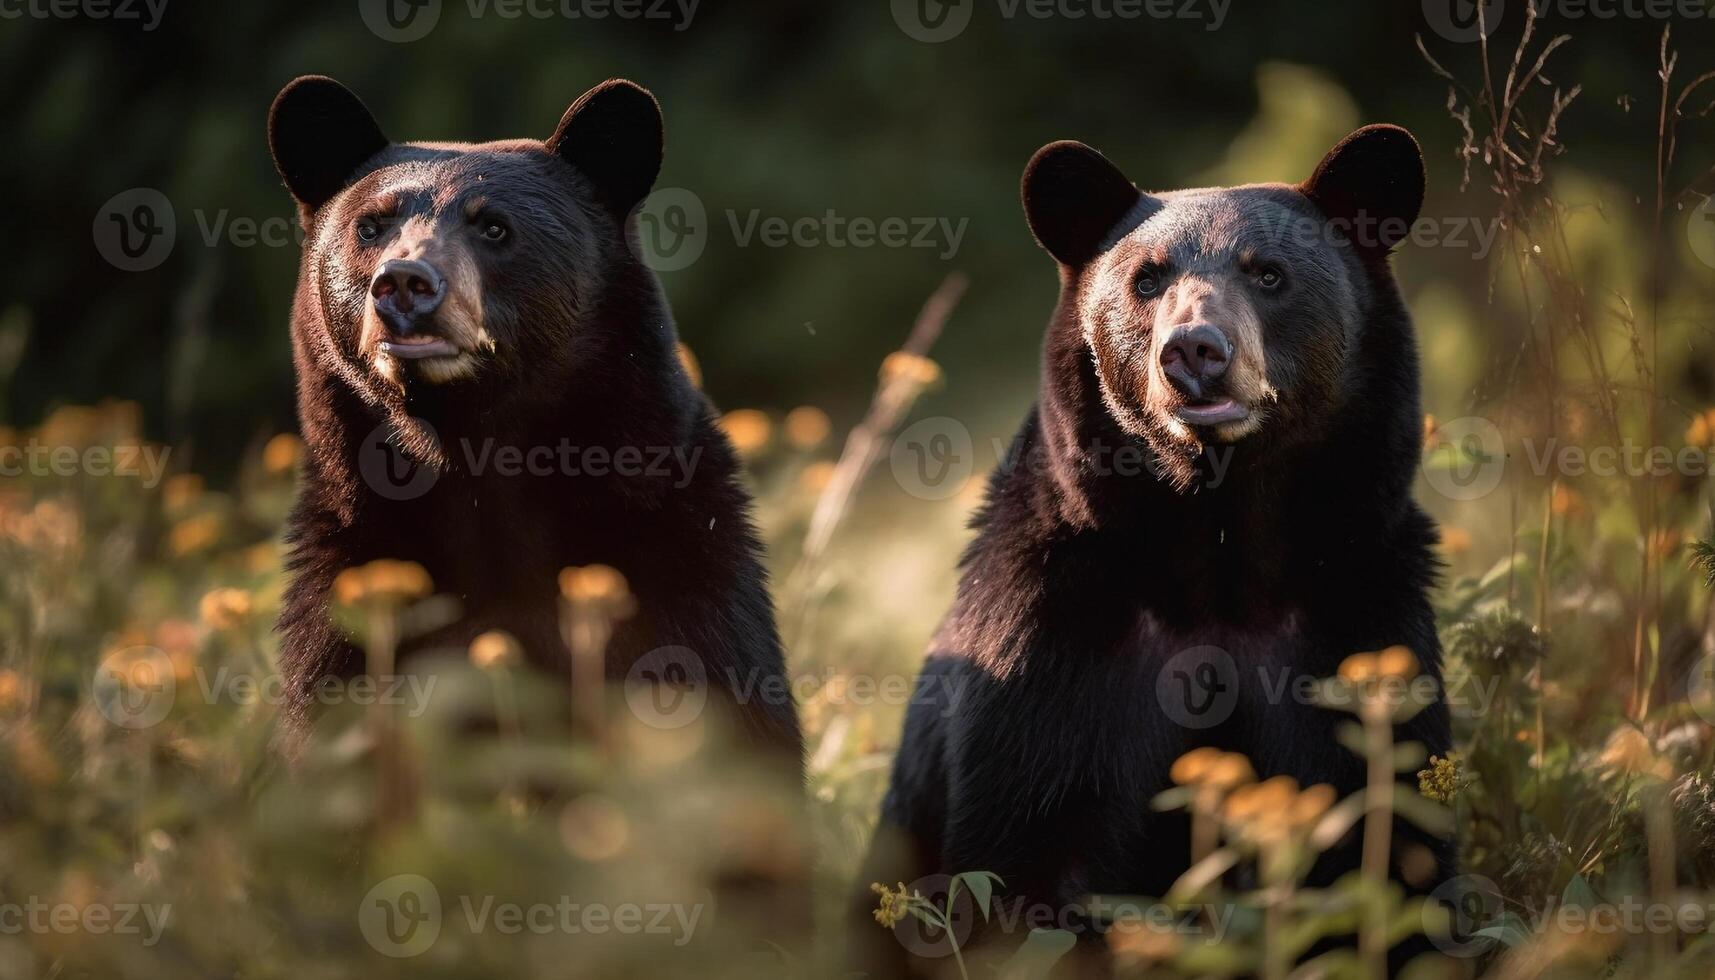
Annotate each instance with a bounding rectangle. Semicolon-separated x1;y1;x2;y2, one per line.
863;125;1451;971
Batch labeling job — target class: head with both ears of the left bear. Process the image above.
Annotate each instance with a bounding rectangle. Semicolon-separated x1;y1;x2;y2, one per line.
268;76;662;394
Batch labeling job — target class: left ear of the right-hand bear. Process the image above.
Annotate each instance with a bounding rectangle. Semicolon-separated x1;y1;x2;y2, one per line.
1022;141;1140;266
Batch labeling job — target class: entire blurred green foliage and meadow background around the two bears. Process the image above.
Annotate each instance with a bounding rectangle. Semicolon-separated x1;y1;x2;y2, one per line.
10;0;1715;980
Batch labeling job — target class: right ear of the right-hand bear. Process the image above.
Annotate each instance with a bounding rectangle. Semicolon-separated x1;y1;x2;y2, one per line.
1298;125;1425;256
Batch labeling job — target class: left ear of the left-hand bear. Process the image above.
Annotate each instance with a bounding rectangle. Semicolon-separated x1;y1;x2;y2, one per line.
268;76;388;213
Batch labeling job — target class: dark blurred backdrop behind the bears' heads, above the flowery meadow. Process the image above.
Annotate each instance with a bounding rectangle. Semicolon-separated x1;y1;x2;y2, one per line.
0;0;1715;475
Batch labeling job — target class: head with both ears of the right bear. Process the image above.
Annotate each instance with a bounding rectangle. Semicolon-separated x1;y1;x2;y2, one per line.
1024;125;1423;487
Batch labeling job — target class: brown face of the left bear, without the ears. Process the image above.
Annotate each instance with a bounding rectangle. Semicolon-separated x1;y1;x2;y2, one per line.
314;144;619;388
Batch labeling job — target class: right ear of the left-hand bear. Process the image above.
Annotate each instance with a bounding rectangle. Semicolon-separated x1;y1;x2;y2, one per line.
547;79;662;215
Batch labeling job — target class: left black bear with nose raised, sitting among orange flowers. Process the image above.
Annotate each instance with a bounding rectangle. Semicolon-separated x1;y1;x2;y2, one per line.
269;77;801;774
